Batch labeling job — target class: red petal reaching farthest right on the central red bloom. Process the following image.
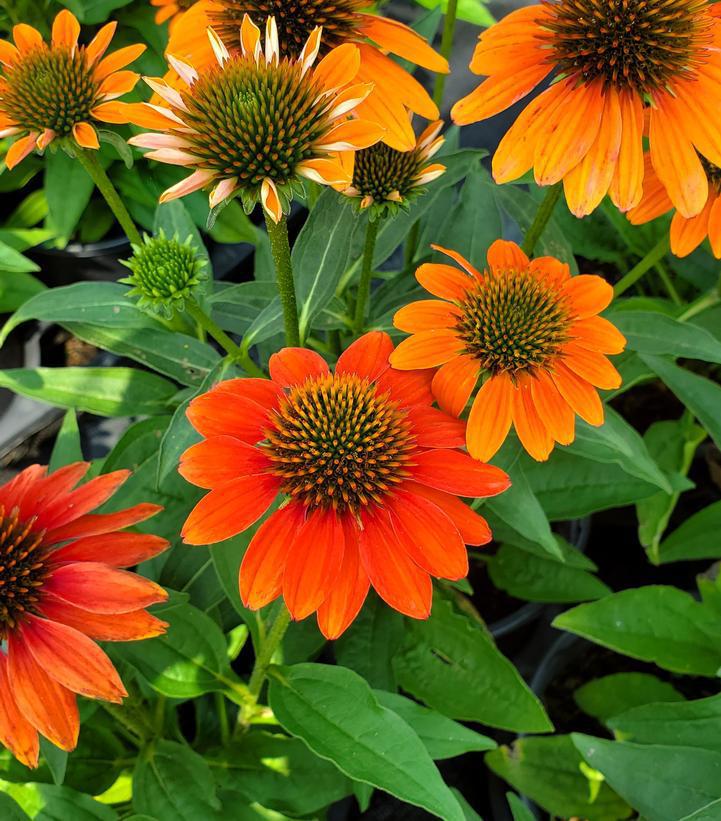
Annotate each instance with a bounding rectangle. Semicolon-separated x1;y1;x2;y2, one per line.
411;450;511;497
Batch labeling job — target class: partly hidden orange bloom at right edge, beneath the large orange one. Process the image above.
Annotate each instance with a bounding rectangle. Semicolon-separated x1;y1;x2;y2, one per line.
628;157;721;259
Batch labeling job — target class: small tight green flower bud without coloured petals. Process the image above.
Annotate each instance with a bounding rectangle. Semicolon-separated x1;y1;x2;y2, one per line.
118;234;208;319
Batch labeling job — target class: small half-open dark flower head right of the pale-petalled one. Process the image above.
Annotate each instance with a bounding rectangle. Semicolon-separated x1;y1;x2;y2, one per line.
341;120;446;217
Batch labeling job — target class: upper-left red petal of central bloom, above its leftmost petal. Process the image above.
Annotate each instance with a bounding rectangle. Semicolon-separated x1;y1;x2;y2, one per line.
186;389;269;445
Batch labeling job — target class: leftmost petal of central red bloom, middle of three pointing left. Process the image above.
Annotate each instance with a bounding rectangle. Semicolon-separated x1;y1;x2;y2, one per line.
178;436;273;488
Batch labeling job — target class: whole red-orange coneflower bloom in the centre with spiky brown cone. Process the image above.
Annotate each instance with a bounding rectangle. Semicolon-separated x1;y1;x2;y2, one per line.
180;332;510;638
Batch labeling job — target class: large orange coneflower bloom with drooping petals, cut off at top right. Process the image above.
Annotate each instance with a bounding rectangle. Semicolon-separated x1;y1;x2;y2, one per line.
452;0;721;217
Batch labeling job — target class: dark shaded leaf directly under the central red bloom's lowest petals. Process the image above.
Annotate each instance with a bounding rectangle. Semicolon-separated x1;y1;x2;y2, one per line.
333;593;403;690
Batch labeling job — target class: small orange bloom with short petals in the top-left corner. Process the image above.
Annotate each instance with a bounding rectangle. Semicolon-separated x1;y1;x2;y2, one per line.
0;10;145;168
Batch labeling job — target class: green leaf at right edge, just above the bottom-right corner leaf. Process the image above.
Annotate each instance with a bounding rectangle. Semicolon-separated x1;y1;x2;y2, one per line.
608;695;721;753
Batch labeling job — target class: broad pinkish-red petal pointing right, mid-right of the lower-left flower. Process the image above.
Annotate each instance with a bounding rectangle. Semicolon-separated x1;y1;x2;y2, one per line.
43;562;168;614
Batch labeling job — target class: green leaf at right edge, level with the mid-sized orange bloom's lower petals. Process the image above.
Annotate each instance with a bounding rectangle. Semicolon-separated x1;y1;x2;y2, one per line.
608;311;721;364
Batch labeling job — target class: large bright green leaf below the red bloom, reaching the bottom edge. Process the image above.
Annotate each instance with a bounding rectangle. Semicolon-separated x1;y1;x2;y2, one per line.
269;664;464;821
